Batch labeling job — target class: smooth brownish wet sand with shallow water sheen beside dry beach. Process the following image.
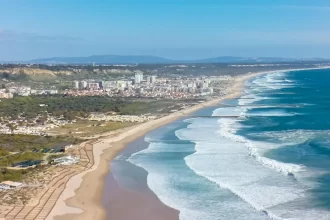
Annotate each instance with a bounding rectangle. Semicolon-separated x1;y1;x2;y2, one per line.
102;137;179;220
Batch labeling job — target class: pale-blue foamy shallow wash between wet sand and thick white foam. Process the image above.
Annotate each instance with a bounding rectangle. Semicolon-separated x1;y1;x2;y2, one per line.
129;137;267;220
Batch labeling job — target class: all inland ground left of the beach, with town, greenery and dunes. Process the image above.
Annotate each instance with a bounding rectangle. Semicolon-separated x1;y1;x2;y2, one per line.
0;64;235;218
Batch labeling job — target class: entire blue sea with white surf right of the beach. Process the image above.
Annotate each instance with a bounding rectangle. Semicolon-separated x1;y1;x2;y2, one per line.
128;69;330;220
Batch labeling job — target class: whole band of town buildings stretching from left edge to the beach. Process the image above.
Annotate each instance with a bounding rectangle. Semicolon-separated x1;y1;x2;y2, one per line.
0;71;228;99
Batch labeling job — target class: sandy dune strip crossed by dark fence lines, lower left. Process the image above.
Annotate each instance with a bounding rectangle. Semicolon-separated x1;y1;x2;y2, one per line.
0;141;96;220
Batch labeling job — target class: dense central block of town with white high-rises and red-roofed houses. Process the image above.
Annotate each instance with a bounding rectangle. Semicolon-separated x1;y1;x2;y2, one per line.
66;72;218;99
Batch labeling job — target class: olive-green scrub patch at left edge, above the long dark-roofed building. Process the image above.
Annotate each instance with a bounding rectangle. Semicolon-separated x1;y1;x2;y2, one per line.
0;134;82;154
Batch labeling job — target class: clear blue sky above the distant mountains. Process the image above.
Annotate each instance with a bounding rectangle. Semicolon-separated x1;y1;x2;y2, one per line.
0;0;330;61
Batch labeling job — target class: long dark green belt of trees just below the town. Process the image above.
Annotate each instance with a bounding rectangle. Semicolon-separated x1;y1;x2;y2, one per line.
0;95;183;119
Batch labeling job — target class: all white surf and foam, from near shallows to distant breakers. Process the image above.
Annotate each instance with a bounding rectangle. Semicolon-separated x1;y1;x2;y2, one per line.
125;69;330;220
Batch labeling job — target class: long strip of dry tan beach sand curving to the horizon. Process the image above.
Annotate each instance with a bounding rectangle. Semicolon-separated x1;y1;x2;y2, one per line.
46;67;329;220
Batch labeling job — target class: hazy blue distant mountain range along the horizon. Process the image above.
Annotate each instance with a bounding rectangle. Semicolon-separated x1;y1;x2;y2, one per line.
14;55;329;64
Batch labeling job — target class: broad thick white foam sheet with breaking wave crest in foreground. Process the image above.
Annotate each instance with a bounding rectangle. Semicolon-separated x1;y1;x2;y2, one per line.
176;105;330;220
